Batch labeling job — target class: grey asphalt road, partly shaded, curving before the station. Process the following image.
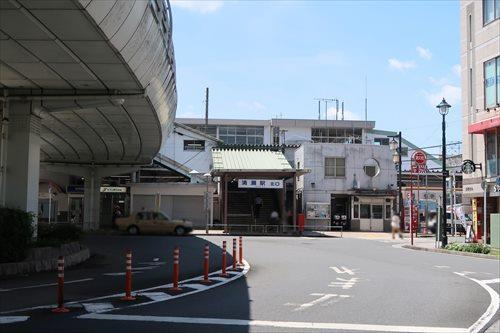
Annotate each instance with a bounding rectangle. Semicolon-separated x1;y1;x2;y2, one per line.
0;236;500;332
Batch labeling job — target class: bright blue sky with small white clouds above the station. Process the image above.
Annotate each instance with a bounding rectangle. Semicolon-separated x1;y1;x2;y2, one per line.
171;0;461;151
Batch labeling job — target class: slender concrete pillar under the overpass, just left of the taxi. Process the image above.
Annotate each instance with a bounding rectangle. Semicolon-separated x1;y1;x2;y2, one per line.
83;170;101;231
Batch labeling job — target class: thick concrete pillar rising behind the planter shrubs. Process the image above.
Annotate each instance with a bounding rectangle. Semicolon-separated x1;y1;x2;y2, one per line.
2;101;41;220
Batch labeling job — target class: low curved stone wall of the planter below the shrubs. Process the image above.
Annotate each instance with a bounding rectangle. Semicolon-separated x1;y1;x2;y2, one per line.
0;242;90;276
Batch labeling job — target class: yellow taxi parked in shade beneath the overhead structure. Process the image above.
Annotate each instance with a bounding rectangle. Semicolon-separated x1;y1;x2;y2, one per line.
116;211;193;236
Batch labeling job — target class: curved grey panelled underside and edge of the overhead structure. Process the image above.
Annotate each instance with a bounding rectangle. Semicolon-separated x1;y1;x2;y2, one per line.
0;0;177;164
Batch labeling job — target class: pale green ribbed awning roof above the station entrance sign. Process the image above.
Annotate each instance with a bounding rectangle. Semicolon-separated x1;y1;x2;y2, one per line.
212;148;293;172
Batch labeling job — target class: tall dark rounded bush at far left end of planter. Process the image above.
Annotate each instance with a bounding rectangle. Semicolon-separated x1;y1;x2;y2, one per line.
0;207;34;262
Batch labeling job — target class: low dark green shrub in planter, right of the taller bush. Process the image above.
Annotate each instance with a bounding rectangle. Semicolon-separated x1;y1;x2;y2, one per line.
37;223;82;246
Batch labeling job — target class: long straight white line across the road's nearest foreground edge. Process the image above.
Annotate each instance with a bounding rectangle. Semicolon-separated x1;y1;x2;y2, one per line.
79;313;468;333
